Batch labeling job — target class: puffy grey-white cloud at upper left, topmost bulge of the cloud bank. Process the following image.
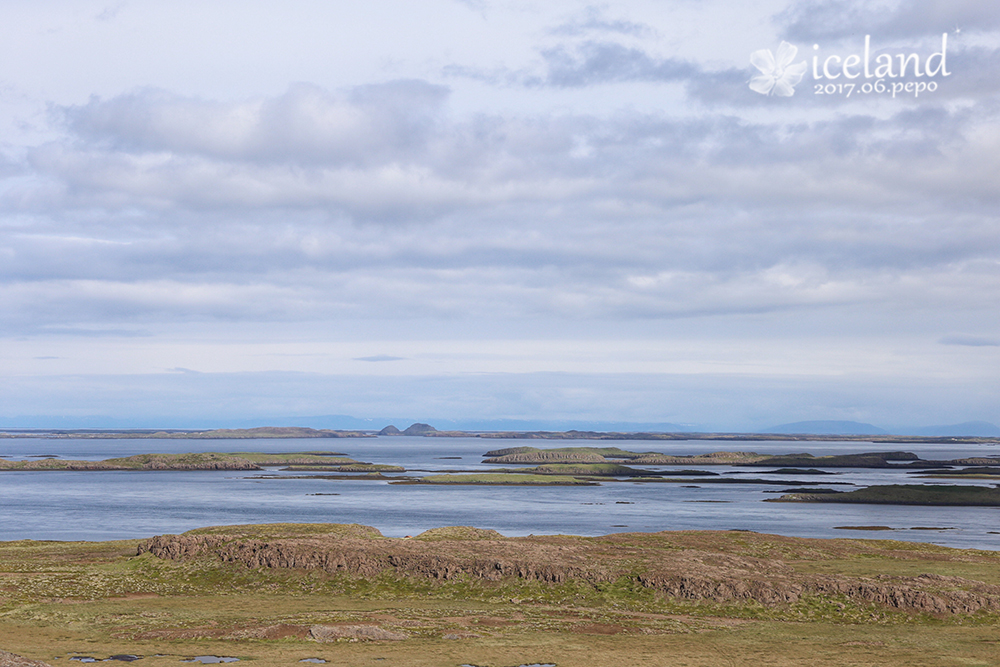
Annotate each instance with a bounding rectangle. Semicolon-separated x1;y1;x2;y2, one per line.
62;81;448;167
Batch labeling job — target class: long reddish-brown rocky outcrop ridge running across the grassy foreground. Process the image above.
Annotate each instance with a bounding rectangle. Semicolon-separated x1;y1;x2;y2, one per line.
139;529;1000;615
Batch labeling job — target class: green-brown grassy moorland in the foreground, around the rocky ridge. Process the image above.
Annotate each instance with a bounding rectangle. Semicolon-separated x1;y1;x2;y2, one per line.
0;524;1000;667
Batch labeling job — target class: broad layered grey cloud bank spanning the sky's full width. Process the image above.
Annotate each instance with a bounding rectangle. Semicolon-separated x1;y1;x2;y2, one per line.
0;82;1000;340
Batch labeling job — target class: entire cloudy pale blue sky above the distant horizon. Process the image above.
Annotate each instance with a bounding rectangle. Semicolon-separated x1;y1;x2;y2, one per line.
0;0;1000;431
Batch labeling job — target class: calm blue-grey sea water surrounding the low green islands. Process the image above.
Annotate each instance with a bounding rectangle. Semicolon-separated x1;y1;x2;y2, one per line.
0;437;1000;550
